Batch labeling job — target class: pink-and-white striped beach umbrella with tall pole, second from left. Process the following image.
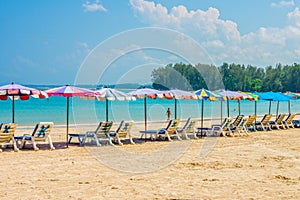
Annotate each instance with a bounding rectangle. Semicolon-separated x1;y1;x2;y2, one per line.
45;85;96;147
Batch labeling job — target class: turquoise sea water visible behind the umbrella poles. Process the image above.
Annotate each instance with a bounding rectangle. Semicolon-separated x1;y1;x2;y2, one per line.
0;97;300;125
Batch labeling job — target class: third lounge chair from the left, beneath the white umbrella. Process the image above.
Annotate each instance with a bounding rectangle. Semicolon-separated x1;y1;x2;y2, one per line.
83;122;114;146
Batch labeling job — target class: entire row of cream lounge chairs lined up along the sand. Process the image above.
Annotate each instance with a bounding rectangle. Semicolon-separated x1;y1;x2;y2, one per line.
0;114;300;152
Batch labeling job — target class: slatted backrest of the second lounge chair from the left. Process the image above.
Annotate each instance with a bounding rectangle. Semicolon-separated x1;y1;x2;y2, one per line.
32;122;54;141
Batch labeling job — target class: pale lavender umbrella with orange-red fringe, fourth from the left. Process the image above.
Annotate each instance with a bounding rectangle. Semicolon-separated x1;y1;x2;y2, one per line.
128;88;164;141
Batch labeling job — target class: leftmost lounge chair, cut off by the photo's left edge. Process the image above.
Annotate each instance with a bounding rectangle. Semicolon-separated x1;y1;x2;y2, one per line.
0;123;19;152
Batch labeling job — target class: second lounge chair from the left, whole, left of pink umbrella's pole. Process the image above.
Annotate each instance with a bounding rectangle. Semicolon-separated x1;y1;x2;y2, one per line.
18;122;55;151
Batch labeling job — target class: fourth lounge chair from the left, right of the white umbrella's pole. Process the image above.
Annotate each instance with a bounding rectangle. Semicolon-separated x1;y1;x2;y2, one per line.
109;121;135;145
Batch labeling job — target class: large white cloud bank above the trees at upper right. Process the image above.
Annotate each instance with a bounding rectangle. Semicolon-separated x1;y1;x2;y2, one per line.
130;0;300;66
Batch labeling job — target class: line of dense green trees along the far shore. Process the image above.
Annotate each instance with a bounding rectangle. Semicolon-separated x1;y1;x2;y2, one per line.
151;63;300;92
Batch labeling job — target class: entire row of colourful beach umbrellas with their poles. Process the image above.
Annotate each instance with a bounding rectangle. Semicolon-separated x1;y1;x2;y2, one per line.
0;83;300;147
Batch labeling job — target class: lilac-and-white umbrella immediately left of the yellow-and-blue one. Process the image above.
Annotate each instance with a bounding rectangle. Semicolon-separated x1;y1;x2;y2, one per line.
163;89;198;119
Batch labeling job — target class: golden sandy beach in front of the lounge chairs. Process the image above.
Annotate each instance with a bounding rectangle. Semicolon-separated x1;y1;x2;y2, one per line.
0;121;300;199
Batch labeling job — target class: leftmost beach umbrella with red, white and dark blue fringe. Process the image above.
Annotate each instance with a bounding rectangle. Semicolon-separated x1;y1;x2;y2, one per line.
0;83;48;123
